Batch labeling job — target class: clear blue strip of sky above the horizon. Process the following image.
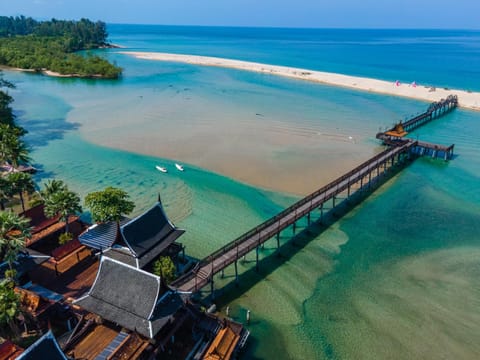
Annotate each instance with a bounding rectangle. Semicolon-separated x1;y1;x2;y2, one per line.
0;0;480;29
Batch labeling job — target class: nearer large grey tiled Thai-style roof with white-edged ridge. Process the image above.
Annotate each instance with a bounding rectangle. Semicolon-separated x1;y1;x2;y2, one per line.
75;256;183;338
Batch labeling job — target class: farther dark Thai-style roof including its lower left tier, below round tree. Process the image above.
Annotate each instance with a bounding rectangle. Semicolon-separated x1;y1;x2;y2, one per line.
98;202;185;268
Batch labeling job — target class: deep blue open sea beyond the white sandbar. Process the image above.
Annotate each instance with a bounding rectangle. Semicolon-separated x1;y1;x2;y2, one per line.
109;25;480;91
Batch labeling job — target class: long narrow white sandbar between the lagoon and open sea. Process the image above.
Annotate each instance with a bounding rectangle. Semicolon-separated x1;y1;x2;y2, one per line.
120;51;480;111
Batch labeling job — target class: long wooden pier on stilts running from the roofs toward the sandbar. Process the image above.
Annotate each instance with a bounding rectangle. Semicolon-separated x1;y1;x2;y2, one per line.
171;96;457;296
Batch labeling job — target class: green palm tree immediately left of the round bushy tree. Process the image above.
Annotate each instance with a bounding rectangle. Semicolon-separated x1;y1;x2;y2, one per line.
43;180;82;233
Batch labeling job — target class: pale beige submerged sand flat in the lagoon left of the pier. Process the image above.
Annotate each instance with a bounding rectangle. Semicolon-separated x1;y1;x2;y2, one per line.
74;90;379;195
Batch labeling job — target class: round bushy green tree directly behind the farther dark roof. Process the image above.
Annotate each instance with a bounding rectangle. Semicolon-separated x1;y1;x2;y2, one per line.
85;186;135;223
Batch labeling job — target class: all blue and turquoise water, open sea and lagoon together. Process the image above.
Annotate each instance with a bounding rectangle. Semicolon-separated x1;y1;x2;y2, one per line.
3;24;480;360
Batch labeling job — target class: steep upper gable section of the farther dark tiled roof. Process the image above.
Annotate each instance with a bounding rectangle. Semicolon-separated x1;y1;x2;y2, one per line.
120;203;185;258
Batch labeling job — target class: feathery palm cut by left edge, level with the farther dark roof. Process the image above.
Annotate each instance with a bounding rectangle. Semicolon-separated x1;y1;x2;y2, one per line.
0;211;31;276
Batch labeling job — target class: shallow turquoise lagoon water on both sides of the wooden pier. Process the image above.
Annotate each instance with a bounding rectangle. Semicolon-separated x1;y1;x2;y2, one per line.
6;26;480;359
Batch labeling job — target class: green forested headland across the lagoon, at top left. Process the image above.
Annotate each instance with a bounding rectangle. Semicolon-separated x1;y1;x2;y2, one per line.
0;16;122;79
